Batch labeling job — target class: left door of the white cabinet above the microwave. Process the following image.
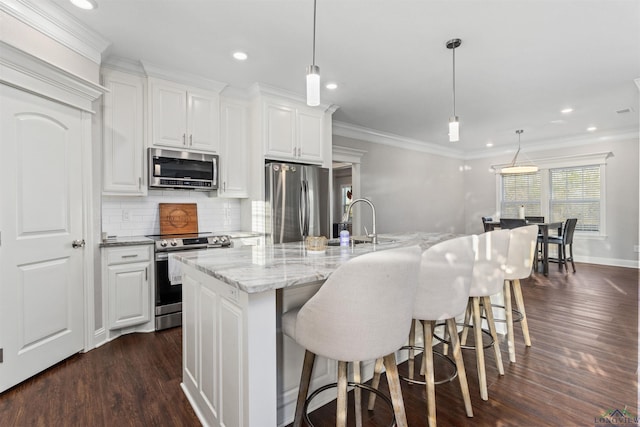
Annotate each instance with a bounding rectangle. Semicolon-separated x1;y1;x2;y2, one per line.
151;81;187;148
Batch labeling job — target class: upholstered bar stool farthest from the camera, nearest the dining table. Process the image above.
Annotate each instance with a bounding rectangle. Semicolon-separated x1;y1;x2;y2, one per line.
504;224;538;363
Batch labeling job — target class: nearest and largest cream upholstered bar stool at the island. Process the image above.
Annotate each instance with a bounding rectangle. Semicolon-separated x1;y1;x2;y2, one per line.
282;246;422;427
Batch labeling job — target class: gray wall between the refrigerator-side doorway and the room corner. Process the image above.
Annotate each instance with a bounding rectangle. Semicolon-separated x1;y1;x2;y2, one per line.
333;135;465;234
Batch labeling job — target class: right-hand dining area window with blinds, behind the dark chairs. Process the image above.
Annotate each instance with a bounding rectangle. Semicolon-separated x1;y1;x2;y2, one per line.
549;166;601;232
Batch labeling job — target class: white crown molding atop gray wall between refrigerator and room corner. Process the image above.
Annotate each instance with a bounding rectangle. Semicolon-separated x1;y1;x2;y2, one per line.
333;121;465;159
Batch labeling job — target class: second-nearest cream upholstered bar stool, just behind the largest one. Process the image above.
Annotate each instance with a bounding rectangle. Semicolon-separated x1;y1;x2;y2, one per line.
369;235;478;427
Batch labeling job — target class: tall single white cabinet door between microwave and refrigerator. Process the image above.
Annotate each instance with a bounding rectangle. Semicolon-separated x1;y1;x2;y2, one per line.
218;102;249;197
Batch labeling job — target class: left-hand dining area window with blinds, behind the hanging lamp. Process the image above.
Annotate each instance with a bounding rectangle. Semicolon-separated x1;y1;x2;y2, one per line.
500;171;542;218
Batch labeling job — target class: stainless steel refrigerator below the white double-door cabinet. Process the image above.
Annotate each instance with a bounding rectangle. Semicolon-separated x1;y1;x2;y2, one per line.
265;163;331;243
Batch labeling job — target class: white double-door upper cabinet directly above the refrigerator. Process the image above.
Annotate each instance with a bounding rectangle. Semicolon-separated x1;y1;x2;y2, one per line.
263;99;325;164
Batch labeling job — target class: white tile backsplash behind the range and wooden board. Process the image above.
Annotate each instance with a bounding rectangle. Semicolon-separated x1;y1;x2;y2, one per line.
102;190;240;236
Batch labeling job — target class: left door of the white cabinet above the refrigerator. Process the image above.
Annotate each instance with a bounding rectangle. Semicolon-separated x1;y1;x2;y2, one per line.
264;103;298;159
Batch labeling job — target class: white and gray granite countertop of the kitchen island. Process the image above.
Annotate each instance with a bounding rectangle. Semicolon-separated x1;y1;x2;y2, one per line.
170;233;459;293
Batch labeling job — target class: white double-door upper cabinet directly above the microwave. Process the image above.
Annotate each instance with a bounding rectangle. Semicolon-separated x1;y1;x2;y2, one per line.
149;77;220;153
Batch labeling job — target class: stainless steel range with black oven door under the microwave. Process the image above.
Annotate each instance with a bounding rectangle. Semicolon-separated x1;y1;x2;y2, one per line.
147;233;231;331
